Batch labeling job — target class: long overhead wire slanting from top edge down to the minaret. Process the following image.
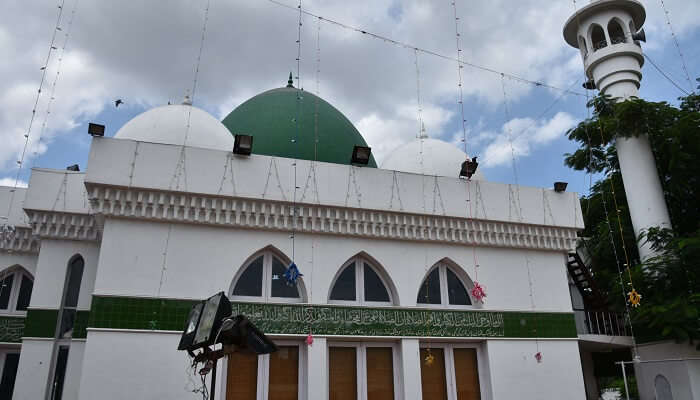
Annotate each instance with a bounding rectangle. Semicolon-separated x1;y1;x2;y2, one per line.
267;0;585;96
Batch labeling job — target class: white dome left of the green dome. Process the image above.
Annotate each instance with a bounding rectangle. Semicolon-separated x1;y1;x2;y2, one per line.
114;104;233;150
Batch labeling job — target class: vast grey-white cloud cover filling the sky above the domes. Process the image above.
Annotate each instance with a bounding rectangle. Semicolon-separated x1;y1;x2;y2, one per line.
0;0;700;175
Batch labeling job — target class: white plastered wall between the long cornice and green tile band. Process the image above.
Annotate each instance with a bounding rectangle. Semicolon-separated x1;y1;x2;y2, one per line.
95;219;571;312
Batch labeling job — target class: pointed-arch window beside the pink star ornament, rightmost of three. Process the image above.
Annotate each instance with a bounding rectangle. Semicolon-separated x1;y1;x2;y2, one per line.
416;257;477;307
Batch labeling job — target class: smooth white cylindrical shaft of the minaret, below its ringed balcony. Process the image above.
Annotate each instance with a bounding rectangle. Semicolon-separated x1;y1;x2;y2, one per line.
605;82;671;260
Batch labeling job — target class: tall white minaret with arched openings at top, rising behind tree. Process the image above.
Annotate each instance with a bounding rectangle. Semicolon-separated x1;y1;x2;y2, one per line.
564;0;671;260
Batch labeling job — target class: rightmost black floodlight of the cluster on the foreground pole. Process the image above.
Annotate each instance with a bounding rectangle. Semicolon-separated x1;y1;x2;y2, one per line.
217;315;277;354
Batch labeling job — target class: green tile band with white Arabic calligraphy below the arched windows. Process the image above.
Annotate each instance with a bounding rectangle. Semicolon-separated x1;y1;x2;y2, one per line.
89;296;577;338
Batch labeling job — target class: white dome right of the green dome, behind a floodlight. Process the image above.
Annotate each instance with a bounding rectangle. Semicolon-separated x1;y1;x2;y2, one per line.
382;138;485;180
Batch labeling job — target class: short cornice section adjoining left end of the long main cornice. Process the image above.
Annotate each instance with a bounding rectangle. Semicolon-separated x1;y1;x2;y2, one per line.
24;209;100;241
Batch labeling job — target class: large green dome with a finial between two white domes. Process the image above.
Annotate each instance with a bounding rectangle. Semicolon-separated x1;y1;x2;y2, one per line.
222;77;377;168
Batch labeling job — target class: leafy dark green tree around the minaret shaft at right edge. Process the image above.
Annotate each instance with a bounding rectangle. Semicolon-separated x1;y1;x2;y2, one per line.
565;91;700;348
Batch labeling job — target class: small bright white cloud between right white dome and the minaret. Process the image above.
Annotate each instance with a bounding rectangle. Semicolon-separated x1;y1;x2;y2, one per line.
481;112;576;168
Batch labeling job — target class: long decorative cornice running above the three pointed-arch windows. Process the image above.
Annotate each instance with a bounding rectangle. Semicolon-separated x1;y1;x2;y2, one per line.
87;184;577;251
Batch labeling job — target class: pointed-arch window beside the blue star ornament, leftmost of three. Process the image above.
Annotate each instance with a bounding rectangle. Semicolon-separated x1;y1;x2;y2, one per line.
231;249;304;303
